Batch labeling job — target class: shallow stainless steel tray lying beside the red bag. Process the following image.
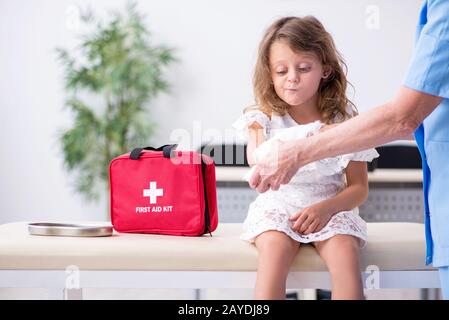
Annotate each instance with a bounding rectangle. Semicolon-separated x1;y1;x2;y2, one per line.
28;222;112;237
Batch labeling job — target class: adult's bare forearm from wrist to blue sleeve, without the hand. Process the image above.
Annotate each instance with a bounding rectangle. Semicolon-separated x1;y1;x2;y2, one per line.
297;87;441;165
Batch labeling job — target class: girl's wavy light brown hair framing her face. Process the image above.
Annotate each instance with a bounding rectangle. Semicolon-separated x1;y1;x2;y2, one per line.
245;16;357;124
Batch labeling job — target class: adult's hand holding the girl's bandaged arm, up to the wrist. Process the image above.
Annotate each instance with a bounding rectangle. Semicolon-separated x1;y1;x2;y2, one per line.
249;140;301;193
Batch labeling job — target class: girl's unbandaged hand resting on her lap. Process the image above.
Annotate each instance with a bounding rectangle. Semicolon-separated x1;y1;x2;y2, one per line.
289;203;332;234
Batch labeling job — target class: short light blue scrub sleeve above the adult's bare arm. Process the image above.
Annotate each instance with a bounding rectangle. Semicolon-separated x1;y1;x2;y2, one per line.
404;0;449;99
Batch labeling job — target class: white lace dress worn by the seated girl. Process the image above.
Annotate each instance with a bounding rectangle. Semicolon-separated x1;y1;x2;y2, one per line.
233;110;379;247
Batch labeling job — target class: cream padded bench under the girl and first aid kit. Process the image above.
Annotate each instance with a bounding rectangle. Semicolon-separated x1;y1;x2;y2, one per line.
0;222;439;298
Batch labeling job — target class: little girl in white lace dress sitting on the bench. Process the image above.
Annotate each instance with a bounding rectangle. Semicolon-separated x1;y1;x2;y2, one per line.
233;16;378;299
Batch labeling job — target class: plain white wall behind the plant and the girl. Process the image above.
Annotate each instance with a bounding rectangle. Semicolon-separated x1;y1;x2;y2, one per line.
0;0;421;223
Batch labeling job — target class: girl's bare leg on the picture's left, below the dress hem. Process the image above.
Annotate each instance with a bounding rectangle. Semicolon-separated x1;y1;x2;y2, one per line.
254;230;299;300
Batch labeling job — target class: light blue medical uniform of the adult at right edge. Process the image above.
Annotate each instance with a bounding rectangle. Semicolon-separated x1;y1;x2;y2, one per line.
404;0;449;299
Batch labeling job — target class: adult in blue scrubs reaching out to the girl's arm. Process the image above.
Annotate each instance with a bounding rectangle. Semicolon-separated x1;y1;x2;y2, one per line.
250;0;449;299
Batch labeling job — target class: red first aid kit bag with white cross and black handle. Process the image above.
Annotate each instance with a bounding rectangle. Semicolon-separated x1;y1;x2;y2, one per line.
109;145;218;236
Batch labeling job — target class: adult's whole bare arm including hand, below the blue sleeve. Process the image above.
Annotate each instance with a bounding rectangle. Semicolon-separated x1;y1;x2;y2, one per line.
249;86;442;192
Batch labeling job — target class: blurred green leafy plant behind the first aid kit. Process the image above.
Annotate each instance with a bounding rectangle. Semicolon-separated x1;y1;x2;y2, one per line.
56;3;175;215
